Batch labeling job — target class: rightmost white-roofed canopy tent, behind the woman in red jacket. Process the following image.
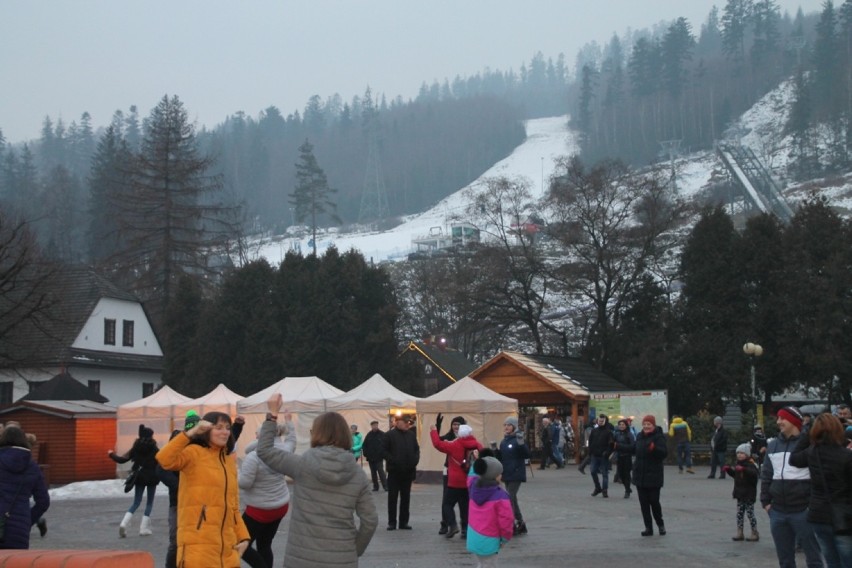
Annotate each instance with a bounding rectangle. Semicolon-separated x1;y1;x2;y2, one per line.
417;377;518;479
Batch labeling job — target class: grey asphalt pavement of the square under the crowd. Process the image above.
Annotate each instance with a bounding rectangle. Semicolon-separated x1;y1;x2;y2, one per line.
30;465;804;568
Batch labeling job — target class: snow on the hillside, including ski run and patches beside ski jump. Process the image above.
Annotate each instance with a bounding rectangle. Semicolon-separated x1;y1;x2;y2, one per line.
250;82;852;265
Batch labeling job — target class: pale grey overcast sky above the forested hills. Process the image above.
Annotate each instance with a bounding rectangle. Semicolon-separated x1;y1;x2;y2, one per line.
0;0;822;142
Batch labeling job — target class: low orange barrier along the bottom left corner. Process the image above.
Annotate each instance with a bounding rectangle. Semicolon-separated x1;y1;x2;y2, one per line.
0;550;154;568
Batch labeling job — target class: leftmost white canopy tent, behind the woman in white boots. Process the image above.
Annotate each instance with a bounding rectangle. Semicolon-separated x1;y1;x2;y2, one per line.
115;386;190;467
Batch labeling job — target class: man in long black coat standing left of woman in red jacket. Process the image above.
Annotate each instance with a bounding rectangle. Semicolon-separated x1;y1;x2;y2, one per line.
383;414;420;531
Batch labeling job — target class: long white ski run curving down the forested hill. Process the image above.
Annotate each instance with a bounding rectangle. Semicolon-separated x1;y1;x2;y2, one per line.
246;116;578;265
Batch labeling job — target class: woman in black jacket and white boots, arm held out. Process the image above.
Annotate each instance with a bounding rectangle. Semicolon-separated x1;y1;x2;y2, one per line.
107;424;160;538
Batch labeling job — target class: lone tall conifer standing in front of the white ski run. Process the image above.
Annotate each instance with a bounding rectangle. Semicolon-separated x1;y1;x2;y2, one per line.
290;139;340;256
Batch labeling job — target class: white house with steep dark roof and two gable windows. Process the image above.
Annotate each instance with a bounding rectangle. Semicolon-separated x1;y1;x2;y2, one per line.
0;267;163;406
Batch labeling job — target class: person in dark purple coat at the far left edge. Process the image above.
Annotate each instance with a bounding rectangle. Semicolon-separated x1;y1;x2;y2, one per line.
0;425;50;549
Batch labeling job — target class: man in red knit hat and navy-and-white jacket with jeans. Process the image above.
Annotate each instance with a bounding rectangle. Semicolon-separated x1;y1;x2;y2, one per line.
760;406;823;568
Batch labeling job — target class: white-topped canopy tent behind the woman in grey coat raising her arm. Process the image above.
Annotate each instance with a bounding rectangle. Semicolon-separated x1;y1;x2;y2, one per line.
237;377;343;457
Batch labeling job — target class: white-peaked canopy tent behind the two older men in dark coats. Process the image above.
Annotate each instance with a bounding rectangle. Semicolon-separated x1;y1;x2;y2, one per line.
326;373;421;434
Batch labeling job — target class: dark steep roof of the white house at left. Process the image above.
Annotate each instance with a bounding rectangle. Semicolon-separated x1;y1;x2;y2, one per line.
3;266;162;370
